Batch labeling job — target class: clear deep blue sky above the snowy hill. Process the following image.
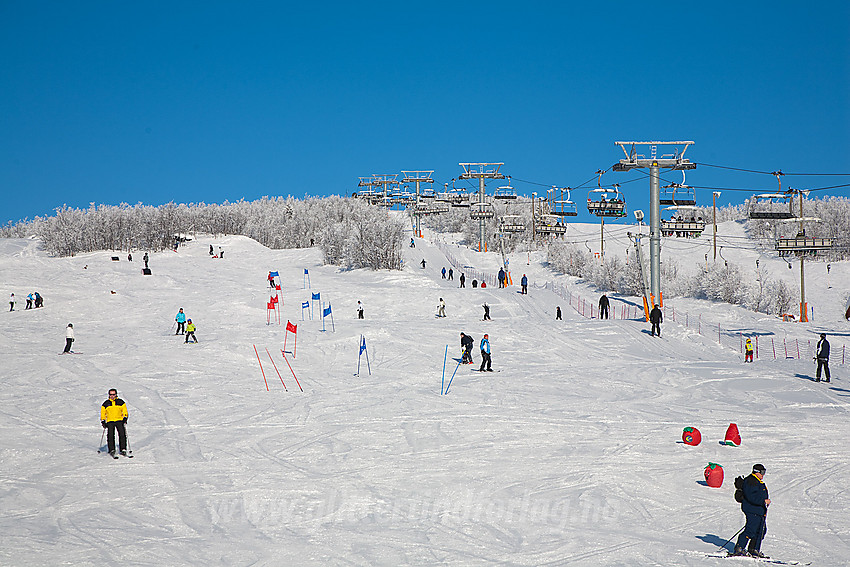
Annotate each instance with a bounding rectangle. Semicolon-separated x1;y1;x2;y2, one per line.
0;1;850;223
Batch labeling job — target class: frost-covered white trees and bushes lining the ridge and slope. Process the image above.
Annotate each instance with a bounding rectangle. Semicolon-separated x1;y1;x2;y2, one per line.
0;196;850;314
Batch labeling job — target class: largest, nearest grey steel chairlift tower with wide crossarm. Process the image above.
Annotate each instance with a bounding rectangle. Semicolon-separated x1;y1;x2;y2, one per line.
613;141;697;317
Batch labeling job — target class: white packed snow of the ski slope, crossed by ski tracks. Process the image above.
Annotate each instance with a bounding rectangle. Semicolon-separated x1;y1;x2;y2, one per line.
0;225;850;566
